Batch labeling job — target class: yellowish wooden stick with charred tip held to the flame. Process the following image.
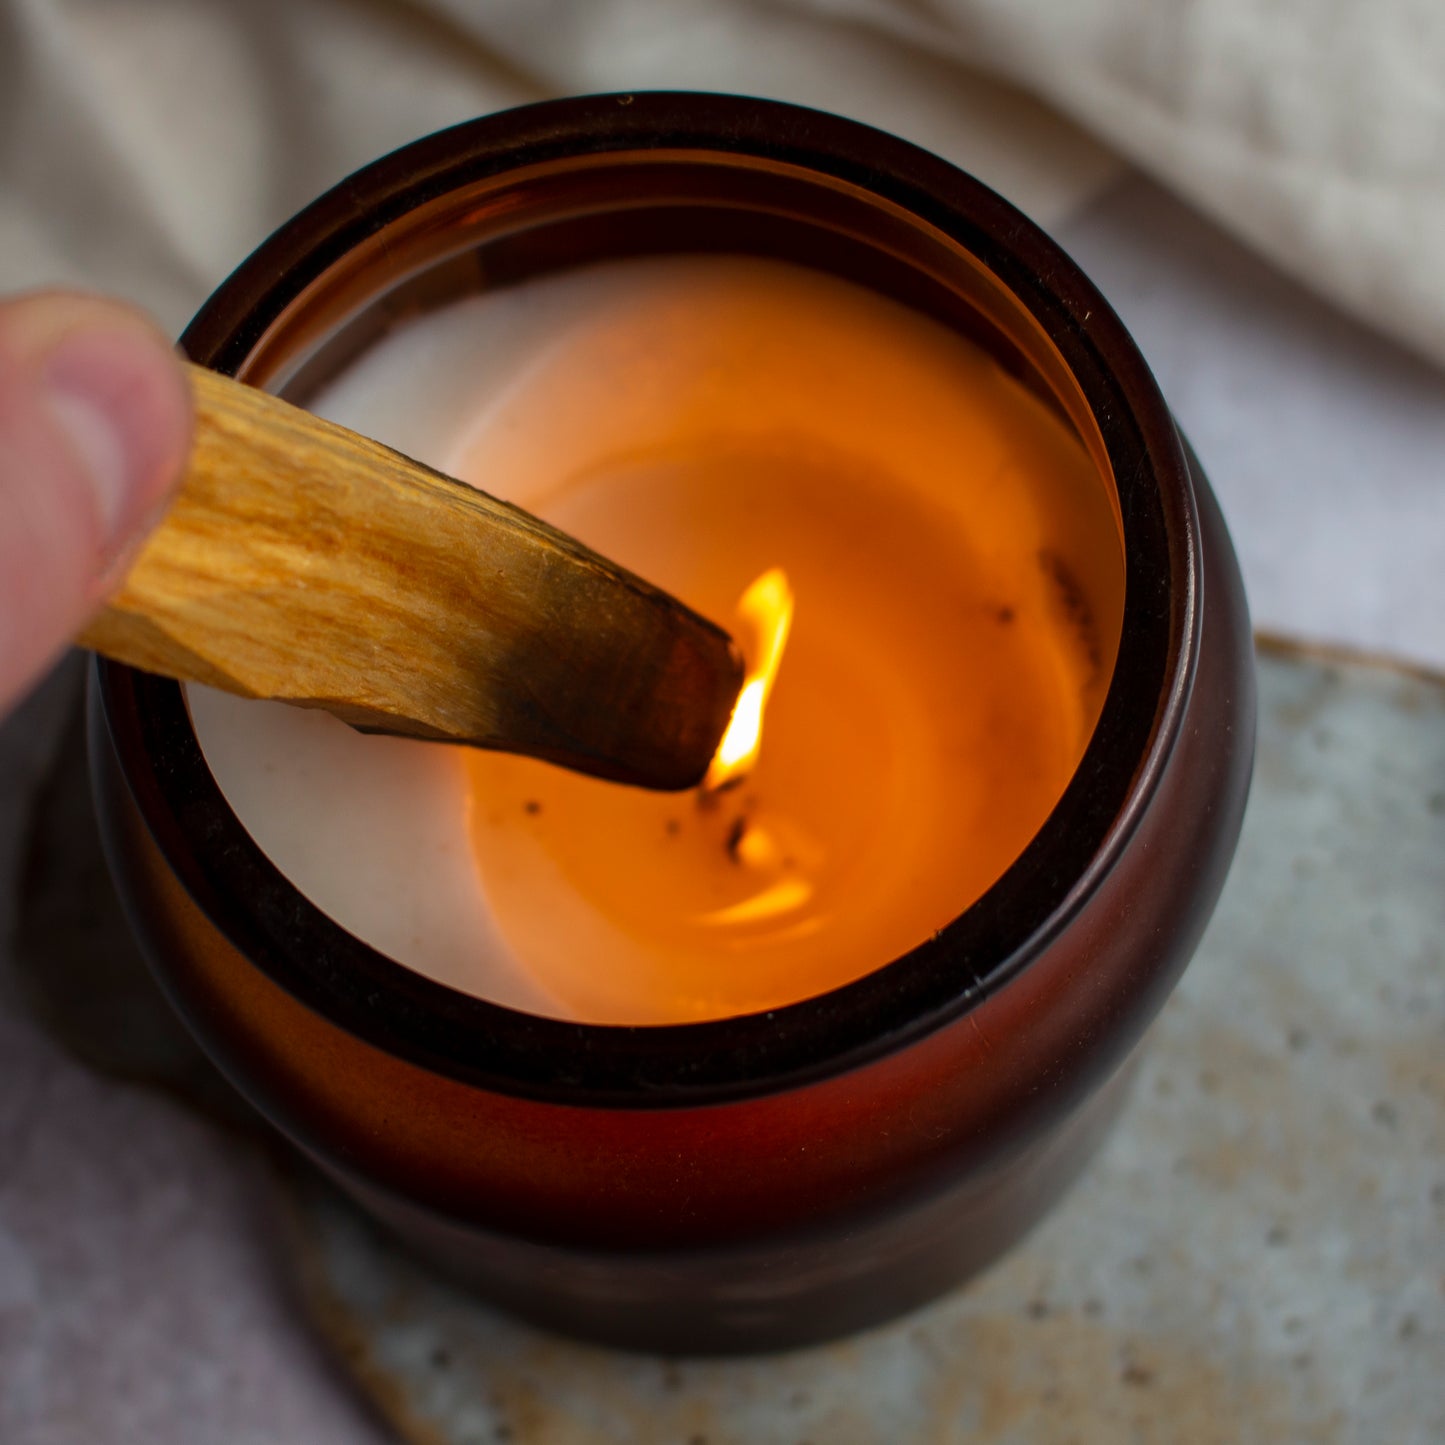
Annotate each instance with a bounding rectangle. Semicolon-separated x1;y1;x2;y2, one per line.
79;367;741;789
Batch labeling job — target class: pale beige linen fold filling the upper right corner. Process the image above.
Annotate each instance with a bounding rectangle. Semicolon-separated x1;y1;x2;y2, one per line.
801;0;1445;363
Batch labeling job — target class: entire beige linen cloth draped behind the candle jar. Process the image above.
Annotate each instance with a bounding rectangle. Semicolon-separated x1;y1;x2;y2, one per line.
8;0;1445;361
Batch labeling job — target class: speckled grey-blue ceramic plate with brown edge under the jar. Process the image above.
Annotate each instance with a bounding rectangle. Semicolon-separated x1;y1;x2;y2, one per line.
14;642;1445;1445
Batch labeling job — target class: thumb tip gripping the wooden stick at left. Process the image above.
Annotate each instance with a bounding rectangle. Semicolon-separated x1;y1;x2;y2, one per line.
0;292;191;712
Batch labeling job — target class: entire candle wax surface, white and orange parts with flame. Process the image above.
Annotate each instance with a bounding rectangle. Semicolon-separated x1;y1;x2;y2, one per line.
191;256;1124;1028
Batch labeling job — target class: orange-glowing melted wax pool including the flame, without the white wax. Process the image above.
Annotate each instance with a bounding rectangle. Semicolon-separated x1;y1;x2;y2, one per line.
447;260;1123;1025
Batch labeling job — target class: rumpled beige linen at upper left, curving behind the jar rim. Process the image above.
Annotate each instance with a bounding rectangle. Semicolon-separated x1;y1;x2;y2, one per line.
0;0;1116;329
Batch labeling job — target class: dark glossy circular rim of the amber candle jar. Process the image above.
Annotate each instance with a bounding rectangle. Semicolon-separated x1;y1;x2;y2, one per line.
97;92;1201;1107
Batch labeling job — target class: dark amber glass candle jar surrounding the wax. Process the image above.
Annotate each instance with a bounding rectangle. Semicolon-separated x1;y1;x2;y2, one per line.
91;94;1254;1351
